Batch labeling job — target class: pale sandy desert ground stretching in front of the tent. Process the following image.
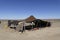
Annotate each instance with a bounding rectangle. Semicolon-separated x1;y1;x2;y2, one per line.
0;22;60;40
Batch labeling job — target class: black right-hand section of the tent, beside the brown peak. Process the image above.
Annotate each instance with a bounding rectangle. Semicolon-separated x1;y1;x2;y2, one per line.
33;19;51;28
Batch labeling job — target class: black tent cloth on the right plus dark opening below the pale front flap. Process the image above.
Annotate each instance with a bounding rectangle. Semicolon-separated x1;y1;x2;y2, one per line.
25;19;51;30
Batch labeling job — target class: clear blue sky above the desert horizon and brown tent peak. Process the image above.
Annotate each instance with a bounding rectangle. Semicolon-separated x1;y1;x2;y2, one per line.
0;0;60;19
